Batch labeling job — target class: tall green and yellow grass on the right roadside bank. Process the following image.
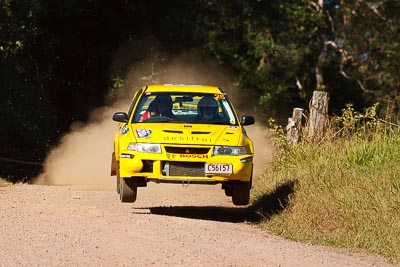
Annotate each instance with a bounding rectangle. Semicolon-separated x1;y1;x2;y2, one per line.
250;105;400;262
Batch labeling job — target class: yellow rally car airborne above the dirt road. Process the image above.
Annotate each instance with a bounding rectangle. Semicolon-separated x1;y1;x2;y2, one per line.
111;84;254;205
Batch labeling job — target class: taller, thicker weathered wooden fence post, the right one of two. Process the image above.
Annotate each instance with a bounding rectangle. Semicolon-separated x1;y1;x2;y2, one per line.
308;91;328;139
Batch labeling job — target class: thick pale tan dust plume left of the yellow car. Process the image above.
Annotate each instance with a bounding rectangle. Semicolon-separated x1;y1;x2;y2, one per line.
35;104;124;190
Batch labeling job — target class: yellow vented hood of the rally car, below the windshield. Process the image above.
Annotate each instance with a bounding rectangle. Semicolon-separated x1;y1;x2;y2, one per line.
129;123;242;146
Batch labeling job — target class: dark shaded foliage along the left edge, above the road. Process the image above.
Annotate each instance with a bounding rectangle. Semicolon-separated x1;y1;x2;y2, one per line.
0;0;55;181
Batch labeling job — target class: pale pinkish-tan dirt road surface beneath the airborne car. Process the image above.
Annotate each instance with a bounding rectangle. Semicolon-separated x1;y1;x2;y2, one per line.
0;184;390;266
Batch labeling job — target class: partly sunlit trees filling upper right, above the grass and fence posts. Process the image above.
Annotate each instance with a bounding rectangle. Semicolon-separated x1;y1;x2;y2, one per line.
190;0;400;119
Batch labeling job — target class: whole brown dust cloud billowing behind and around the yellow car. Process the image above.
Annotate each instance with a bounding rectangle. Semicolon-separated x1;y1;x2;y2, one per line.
34;38;273;191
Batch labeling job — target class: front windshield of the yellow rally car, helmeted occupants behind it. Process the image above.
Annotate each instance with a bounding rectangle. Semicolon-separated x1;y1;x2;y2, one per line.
132;93;237;125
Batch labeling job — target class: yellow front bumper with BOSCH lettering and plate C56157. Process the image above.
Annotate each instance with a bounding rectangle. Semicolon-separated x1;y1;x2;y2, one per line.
119;152;253;184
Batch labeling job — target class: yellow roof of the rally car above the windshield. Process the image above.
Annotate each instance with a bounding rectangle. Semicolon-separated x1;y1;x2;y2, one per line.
144;84;224;94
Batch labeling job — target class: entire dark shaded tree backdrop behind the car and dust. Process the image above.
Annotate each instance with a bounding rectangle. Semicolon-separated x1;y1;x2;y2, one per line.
0;0;400;182
